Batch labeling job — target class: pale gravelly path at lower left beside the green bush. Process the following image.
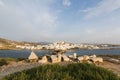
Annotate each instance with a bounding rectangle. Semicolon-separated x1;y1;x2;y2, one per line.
0;63;41;78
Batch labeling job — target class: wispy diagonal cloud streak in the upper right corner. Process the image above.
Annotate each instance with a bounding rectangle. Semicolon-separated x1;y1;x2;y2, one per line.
83;0;120;18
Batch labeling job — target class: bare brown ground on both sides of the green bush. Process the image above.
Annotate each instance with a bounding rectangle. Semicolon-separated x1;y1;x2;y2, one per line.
0;57;120;78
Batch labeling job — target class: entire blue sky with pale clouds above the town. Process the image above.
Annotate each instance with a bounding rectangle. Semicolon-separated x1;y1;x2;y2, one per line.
0;0;120;44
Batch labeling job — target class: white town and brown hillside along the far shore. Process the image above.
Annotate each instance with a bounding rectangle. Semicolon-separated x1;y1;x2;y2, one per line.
0;38;120;50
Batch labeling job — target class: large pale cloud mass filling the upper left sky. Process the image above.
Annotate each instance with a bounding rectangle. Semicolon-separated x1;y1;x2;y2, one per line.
0;0;57;41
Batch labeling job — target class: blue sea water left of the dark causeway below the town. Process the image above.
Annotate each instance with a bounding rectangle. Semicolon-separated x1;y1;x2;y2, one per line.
0;50;52;58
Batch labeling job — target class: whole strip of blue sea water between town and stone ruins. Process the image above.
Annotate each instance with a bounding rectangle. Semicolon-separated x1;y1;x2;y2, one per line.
0;50;120;58
